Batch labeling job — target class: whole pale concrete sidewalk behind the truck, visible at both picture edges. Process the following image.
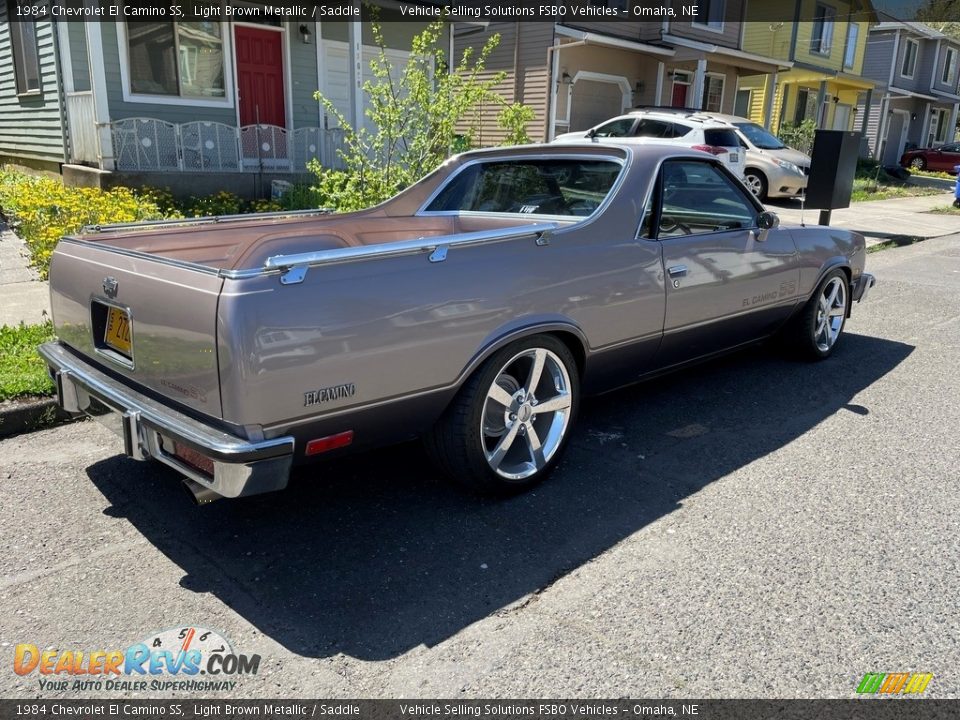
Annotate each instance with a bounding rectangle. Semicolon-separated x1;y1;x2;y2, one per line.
0;192;960;325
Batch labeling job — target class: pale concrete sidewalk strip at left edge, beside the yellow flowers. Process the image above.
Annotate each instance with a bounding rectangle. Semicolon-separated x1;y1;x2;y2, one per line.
0;223;50;325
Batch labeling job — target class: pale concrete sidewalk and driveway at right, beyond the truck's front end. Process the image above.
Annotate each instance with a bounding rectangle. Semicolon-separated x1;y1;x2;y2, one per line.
767;192;960;245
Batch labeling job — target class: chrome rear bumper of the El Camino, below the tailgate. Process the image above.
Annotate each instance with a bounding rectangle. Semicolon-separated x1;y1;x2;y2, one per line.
39;342;294;497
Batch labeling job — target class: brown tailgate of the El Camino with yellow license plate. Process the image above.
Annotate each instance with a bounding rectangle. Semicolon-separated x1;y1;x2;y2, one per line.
50;240;223;418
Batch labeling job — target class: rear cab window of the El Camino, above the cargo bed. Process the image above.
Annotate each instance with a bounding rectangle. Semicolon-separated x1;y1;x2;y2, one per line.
426;158;621;217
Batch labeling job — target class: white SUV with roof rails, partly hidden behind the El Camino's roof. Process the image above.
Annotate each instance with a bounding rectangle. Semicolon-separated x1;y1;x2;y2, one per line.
553;110;746;178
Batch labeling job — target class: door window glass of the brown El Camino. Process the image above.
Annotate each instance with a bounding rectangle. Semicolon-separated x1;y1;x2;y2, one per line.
657;160;757;239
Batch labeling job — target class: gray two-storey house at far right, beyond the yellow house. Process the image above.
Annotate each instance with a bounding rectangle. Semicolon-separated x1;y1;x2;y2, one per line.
861;16;960;165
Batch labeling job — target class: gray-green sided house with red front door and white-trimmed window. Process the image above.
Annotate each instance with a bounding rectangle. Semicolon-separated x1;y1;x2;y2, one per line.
0;0;446;195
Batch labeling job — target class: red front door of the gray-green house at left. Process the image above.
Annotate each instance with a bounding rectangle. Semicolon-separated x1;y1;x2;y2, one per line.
234;27;287;127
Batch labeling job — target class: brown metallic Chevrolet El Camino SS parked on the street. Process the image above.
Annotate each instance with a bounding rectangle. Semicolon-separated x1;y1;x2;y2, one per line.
41;145;874;501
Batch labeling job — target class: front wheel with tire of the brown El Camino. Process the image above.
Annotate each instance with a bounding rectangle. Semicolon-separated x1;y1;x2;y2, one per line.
791;269;850;360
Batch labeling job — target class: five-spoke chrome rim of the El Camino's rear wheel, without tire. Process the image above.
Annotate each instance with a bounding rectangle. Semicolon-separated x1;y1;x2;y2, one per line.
480;347;573;480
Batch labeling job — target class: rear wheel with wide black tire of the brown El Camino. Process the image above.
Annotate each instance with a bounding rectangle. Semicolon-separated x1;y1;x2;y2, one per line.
424;335;580;495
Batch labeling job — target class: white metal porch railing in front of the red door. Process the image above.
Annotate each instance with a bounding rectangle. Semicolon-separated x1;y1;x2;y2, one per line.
110;117;343;173
